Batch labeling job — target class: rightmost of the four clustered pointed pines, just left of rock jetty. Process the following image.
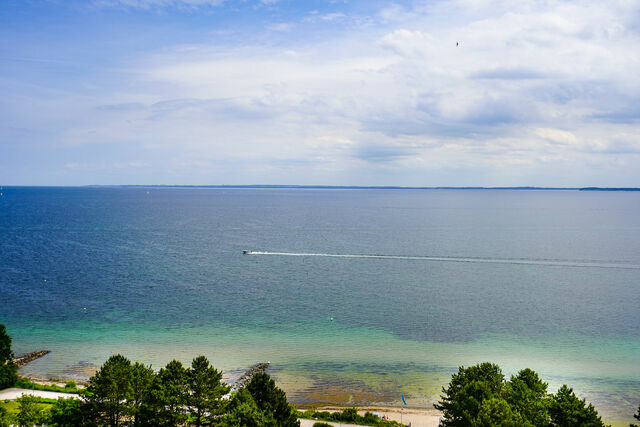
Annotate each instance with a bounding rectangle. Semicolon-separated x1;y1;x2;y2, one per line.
188;356;229;427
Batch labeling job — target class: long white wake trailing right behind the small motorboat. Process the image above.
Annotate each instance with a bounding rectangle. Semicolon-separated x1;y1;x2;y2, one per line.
242;250;640;270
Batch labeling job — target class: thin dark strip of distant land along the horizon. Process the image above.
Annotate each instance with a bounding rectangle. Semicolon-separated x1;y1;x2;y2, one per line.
5;184;640;191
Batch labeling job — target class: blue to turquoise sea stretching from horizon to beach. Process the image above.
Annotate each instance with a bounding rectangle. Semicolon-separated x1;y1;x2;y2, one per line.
0;187;640;425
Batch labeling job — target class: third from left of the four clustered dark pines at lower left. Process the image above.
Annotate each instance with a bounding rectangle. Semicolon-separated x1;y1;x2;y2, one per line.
140;360;188;426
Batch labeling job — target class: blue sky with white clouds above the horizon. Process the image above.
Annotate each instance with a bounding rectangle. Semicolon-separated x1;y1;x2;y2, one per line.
0;0;640;187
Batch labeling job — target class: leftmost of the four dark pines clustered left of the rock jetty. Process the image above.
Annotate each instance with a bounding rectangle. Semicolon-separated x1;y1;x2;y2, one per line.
86;354;132;427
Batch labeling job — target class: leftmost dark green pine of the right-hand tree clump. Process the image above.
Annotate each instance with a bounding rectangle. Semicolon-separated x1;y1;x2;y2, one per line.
433;362;504;427
